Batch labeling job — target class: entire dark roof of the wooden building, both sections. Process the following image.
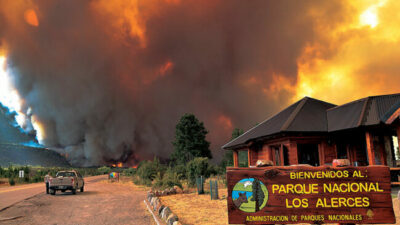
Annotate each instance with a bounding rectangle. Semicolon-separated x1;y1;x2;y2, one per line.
222;94;400;149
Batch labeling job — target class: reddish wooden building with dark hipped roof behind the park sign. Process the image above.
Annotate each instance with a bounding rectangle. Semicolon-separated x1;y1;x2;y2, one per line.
222;94;400;167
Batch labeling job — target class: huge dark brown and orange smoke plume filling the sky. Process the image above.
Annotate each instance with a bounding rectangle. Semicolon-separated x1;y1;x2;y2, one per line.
0;0;399;166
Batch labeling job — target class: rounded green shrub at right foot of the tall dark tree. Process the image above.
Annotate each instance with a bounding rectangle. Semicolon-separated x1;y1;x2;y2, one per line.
186;157;210;186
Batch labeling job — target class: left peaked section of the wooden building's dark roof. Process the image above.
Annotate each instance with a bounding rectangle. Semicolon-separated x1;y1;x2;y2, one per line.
222;97;336;149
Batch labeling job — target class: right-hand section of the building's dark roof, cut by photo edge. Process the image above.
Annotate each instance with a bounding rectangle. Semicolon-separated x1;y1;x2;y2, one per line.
327;94;400;131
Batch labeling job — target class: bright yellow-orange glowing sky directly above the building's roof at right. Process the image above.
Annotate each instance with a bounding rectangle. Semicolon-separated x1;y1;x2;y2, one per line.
292;0;400;104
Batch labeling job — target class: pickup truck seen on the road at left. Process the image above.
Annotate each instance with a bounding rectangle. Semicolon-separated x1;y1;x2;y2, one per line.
49;170;85;195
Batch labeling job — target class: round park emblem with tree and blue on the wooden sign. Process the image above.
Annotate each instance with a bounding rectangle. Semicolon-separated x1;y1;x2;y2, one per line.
232;178;268;212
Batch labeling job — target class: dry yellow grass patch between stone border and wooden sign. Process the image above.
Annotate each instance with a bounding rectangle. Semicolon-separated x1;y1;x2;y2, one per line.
161;189;228;225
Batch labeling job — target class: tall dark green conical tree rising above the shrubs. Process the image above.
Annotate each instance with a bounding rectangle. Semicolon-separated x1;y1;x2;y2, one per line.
171;114;212;165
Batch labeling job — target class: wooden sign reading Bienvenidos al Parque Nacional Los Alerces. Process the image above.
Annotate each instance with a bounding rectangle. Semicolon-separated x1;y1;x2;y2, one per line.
226;166;396;224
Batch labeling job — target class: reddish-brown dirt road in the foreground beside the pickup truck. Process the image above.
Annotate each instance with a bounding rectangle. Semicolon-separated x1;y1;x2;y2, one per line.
0;177;155;225
